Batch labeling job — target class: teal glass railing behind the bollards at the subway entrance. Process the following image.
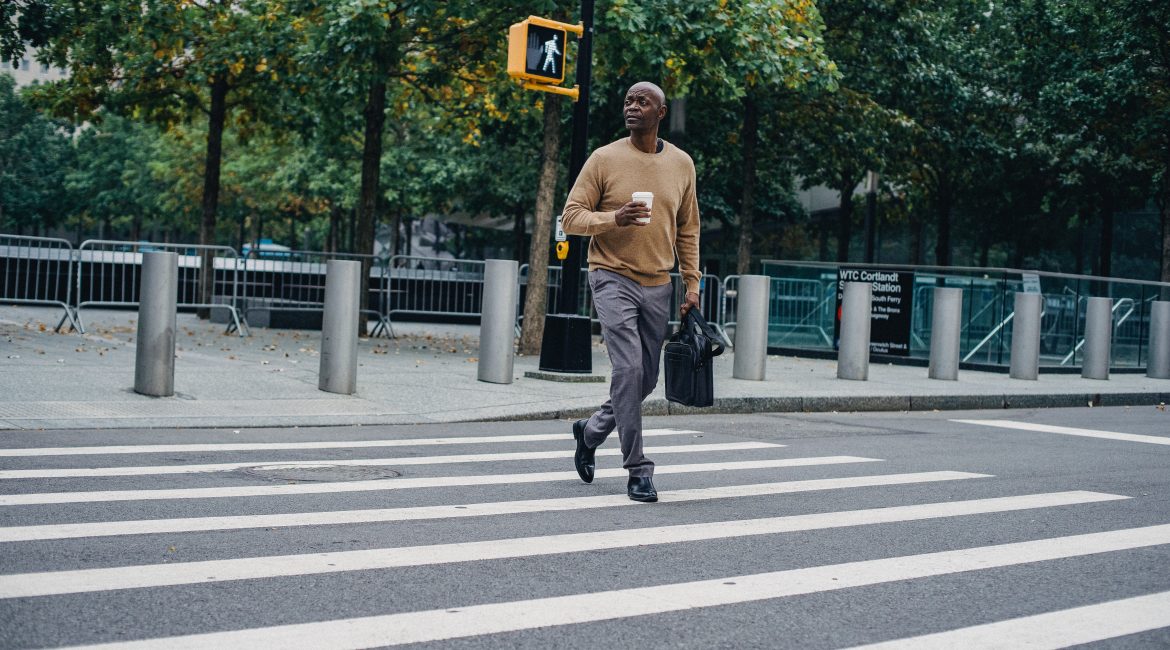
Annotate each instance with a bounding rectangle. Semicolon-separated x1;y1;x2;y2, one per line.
763;261;1170;368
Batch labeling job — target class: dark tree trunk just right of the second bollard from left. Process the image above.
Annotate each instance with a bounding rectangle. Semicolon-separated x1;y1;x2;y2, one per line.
355;77;386;337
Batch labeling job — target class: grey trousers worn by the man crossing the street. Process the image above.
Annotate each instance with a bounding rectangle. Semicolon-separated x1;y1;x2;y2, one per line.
585;269;672;477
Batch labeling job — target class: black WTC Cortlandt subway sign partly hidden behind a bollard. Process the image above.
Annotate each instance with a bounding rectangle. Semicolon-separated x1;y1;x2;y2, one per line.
833;267;914;357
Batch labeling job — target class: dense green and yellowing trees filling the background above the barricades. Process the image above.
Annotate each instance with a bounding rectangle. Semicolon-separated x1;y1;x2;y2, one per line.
0;0;1170;281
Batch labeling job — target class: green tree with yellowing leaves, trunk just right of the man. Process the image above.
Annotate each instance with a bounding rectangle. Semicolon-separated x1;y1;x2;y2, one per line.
598;0;839;272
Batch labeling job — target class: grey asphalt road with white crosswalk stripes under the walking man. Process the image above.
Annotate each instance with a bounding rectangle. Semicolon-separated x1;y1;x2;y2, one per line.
0;407;1170;649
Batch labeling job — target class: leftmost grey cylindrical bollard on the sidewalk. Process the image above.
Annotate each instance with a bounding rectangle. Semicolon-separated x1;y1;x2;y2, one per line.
135;253;179;397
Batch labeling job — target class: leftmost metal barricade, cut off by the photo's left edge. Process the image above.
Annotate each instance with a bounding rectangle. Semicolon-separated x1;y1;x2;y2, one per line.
0;234;81;332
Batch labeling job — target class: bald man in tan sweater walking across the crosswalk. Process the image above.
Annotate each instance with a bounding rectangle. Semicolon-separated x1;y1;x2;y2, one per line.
562;82;701;502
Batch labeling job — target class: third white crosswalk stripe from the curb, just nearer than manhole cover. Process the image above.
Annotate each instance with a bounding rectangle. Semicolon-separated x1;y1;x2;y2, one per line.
0;456;881;506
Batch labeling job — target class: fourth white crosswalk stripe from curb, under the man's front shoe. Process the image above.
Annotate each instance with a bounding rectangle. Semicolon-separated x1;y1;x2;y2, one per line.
0;471;990;542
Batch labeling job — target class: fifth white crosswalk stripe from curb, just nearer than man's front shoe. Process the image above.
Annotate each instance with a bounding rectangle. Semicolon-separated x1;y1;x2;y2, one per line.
0;491;1129;599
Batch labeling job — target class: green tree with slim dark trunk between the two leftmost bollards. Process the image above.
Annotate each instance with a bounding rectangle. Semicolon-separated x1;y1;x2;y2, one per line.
31;0;302;313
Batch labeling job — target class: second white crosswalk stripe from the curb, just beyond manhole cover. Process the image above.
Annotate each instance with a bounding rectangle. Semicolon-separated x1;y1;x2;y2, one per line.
0;438;784;480
